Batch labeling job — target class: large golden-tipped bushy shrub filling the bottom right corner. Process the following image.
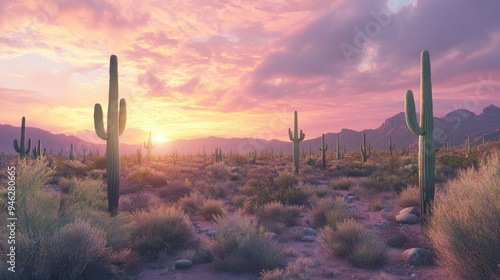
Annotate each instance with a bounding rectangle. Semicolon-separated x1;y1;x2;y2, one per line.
428;151;500;279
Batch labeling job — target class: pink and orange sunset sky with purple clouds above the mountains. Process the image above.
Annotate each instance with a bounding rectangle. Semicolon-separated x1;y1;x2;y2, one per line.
0;0;500;144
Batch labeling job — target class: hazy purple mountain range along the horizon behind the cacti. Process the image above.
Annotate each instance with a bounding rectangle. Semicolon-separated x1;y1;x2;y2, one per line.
0;105;500;155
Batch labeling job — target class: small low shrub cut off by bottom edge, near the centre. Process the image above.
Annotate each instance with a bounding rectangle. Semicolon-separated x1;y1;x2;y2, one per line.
260;258;314;280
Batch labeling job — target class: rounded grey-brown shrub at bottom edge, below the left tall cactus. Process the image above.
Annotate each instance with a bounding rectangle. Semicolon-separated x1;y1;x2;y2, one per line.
40;221;112;280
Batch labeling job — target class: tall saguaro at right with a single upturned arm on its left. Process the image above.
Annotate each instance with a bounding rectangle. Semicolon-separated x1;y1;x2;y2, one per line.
405;51;436;225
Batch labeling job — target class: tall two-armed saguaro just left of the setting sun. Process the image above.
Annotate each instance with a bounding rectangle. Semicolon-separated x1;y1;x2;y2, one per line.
94;55;127;216
